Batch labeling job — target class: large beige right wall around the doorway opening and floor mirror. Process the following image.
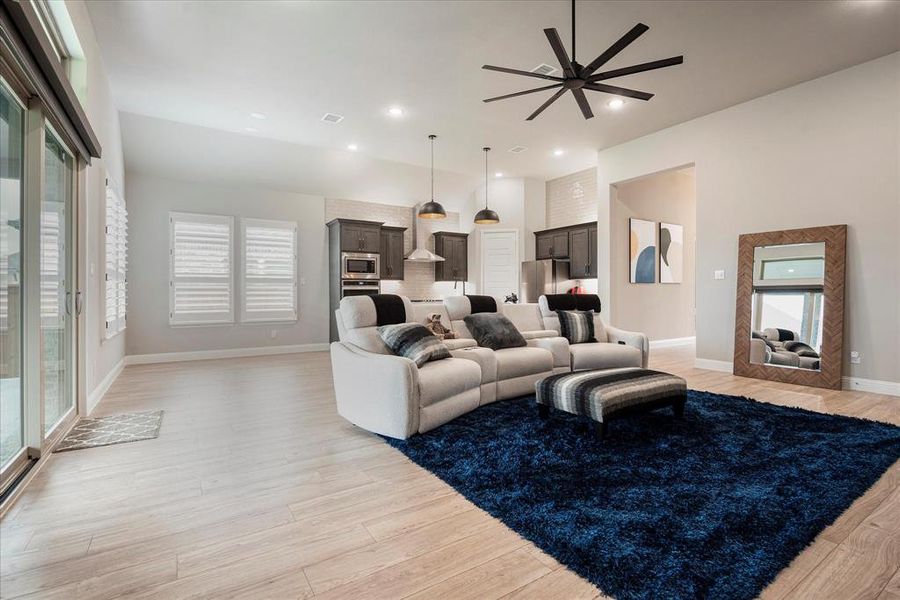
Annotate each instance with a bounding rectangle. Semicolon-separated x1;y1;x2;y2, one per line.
598;53;900;382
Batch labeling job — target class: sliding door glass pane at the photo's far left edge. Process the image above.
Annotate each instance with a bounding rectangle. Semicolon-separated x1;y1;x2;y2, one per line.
0;80;25;474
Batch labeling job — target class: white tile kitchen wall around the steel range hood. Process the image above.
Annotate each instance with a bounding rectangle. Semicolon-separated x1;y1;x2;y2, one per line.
325;198;472;299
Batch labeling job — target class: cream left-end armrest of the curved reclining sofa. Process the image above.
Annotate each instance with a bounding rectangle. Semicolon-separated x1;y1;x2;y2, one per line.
331;342;419;439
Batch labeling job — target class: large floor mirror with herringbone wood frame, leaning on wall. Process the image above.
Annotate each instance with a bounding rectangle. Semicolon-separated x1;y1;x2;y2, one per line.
734;225;847;389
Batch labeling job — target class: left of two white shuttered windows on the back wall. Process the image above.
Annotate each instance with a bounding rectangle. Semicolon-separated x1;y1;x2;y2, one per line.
169;212;234;325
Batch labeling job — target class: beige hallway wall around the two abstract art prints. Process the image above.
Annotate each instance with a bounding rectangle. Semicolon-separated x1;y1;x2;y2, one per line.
610;170;696;340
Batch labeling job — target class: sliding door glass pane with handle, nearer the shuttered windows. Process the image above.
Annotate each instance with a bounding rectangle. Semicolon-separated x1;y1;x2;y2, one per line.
40;128;75;436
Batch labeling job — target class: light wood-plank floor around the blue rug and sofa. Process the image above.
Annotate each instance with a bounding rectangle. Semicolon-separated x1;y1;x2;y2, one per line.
0;347;900;600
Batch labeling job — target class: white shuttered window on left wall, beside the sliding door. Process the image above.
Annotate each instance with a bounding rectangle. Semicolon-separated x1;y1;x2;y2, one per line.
104;178;128;339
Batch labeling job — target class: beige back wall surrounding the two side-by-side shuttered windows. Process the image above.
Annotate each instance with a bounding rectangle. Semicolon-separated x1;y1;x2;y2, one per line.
125;173;329;355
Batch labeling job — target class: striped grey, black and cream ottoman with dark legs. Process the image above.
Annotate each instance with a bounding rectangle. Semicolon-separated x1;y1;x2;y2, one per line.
534;368;687;439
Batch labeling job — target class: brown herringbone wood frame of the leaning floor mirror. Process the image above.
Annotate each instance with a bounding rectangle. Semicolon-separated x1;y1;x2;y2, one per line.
734;225;847;390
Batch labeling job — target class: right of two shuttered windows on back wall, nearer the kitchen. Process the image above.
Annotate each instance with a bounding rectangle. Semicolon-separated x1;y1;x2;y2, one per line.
241;219;297;322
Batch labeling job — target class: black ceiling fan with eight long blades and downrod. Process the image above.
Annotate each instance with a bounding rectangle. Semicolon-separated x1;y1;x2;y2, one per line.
481;0;684;121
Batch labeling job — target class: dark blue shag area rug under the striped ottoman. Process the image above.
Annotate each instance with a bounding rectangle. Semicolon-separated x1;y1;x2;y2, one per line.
387;391;900;600
